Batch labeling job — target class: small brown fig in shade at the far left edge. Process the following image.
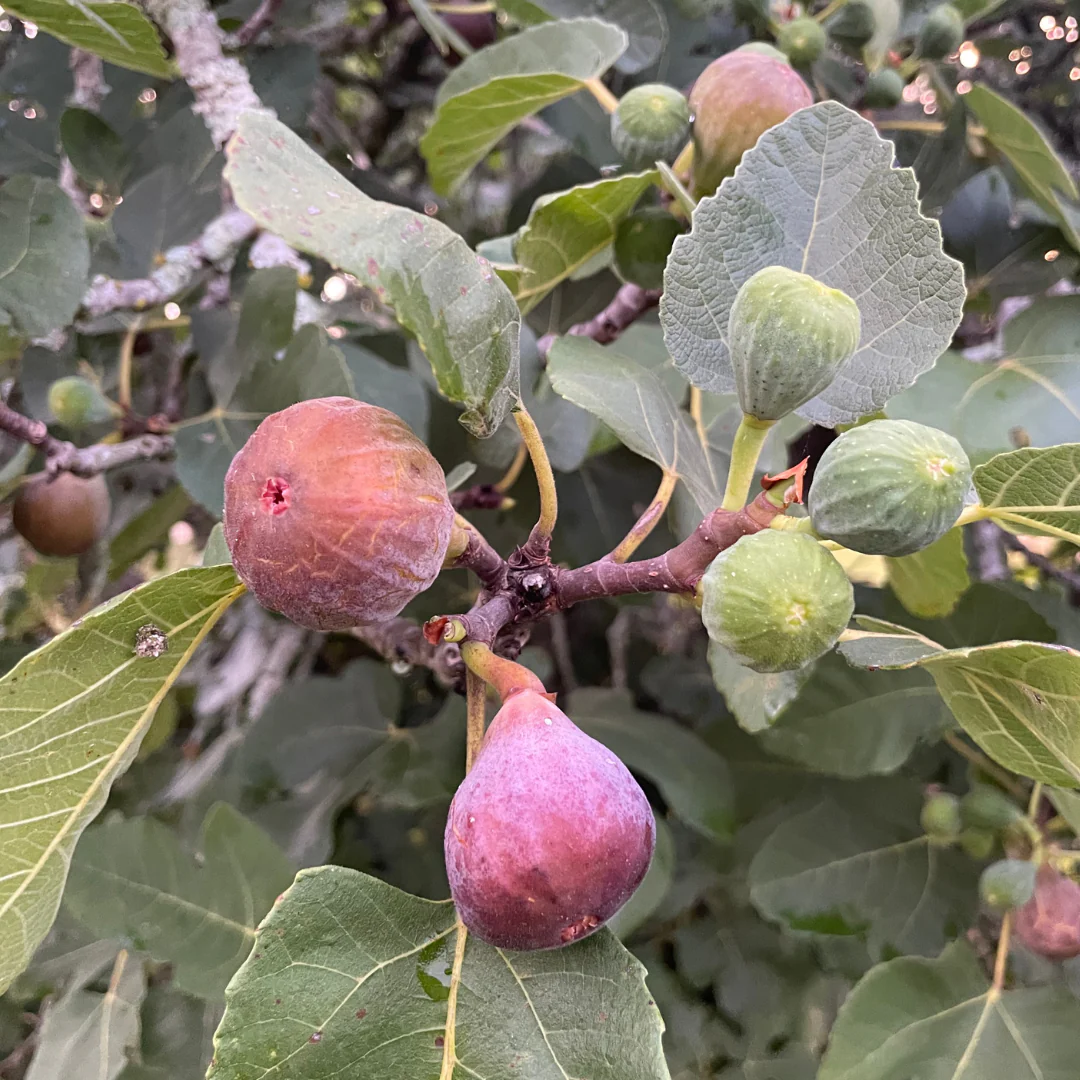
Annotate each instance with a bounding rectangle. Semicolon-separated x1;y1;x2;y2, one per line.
12;472;111;556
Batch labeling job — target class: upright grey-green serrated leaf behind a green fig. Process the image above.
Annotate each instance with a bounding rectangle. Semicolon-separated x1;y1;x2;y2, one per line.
660;102;966;427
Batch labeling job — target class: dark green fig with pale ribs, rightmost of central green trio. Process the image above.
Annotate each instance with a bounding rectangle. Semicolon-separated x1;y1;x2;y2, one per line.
808;420;971;556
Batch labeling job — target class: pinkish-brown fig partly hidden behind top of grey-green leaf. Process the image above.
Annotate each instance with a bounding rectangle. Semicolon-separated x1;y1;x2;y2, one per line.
690;49;813;199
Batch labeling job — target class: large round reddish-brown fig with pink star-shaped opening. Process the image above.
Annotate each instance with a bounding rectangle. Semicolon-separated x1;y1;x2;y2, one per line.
222;397;454;630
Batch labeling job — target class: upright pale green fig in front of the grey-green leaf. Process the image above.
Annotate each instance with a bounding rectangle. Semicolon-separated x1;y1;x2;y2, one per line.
728;267;861;420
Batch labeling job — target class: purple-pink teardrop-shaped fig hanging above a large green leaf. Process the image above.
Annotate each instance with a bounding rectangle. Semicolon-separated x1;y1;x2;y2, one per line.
445;690;656;949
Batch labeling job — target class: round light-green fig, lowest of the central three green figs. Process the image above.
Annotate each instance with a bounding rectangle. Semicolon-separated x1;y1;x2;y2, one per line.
698;529;854;672
